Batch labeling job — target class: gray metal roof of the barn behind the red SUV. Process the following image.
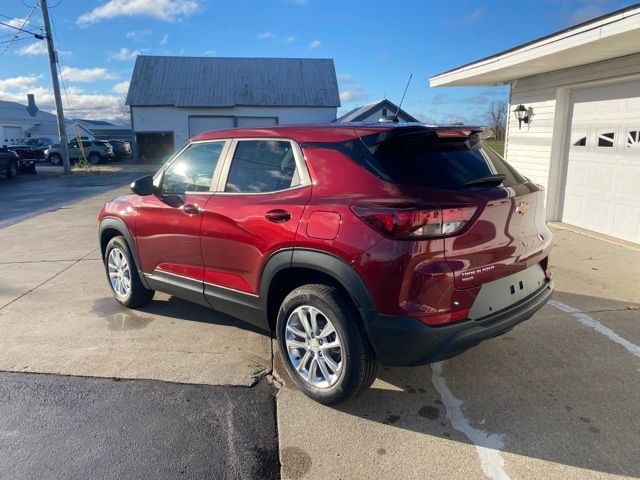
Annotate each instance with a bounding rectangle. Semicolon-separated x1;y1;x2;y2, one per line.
127;55;340;107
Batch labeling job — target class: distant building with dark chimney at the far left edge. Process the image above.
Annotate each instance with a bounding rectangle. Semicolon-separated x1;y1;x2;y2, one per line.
0;94;58;145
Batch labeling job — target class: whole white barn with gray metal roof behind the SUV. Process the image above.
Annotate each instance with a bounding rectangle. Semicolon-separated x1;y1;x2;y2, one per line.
127;56;340;158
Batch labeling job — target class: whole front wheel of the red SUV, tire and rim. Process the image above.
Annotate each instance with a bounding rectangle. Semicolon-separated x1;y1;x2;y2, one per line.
104;236;155;308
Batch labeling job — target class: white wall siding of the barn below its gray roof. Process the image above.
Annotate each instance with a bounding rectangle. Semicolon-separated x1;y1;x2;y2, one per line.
131;106;337;148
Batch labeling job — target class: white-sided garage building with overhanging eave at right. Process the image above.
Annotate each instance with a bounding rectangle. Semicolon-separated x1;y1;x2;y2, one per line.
430;4;640;243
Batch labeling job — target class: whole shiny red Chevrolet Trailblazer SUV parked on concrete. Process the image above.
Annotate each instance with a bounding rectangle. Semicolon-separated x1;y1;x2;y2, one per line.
99;124;553;404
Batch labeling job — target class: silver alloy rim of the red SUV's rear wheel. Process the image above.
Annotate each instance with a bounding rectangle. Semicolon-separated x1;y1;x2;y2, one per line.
285;305;344;389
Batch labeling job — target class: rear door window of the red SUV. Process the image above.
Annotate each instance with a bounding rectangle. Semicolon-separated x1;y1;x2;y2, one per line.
225;140;300;193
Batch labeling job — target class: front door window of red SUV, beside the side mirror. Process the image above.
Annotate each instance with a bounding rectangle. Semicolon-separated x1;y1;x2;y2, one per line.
160;142;225;194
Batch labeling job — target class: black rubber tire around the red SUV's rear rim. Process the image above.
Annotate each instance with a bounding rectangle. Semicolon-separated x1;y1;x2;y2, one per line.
276;284;378;405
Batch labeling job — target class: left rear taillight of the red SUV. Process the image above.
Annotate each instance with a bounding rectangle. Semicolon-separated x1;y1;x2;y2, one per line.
351;205;476;239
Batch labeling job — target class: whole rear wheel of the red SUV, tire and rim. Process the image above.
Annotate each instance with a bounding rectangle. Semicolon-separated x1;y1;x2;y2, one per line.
276;285;378;405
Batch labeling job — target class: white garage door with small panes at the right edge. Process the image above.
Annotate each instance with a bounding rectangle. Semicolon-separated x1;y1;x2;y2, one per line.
562;81;640;243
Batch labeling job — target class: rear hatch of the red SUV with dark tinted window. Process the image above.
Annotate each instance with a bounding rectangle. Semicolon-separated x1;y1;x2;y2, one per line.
361;127;551;293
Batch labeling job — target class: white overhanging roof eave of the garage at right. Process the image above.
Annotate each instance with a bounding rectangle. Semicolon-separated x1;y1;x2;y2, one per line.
429;4;640;87
